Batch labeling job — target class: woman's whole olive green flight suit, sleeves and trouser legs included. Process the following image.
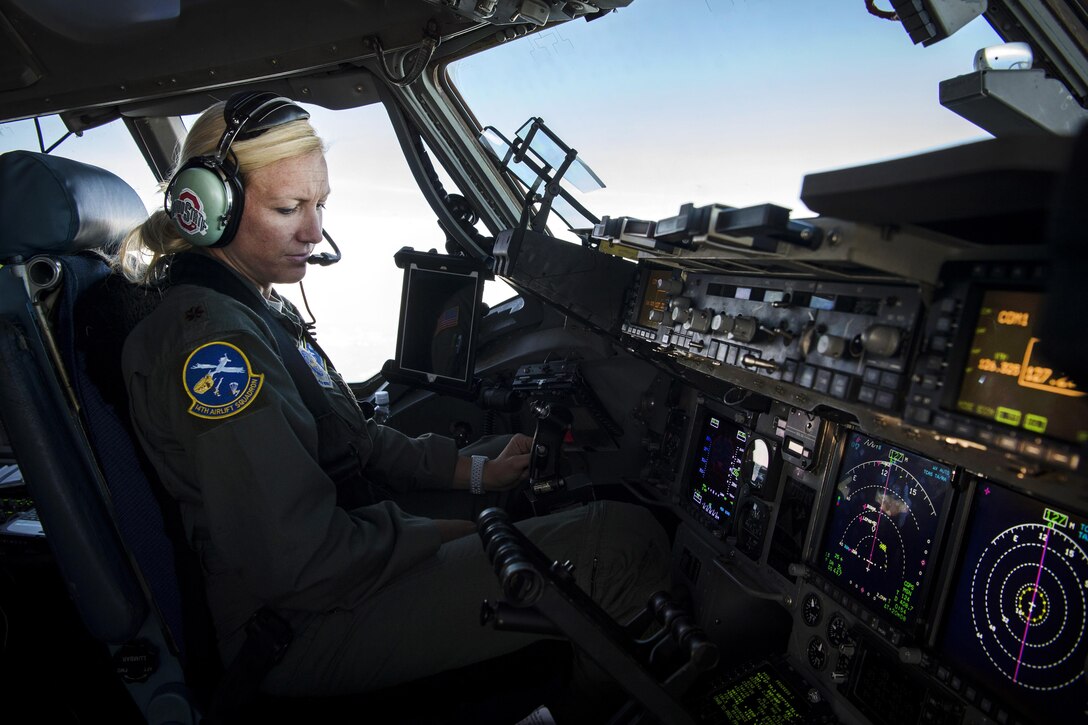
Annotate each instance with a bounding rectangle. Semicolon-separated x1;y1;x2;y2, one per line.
123;256;669;695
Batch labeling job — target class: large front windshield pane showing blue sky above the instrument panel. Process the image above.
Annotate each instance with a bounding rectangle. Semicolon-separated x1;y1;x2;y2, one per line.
448;0;1001;224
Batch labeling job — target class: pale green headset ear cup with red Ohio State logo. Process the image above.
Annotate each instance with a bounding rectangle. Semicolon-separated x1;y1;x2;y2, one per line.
164;157;244;247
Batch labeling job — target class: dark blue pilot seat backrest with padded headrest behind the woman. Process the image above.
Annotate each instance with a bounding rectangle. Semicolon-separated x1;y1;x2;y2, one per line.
0;151;202;722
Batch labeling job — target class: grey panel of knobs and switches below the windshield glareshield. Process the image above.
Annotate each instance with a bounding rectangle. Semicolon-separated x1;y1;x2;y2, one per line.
622;267;922;413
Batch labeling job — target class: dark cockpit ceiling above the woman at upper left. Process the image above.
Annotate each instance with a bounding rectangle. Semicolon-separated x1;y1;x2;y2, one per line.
0;0;596;121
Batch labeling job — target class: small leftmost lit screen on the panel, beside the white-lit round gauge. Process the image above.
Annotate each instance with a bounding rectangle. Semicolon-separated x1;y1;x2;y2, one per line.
688;413;750;531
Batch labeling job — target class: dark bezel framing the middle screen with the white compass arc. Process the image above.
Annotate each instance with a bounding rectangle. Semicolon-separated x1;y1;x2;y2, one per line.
808;429;962;641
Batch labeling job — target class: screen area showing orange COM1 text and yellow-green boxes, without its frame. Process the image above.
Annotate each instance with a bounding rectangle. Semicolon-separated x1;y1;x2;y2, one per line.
955;290;1088;443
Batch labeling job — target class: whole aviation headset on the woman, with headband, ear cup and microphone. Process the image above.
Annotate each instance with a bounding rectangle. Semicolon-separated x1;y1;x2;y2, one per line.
163;93;311;248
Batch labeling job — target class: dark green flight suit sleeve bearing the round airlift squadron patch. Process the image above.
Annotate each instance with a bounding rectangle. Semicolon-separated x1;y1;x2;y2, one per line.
125;296;441;611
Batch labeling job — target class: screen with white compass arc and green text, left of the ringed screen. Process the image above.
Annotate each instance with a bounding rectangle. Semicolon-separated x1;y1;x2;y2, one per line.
820;433;952;628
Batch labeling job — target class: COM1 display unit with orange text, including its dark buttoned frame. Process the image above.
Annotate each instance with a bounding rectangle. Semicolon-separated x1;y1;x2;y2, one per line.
903;262;1088;471
